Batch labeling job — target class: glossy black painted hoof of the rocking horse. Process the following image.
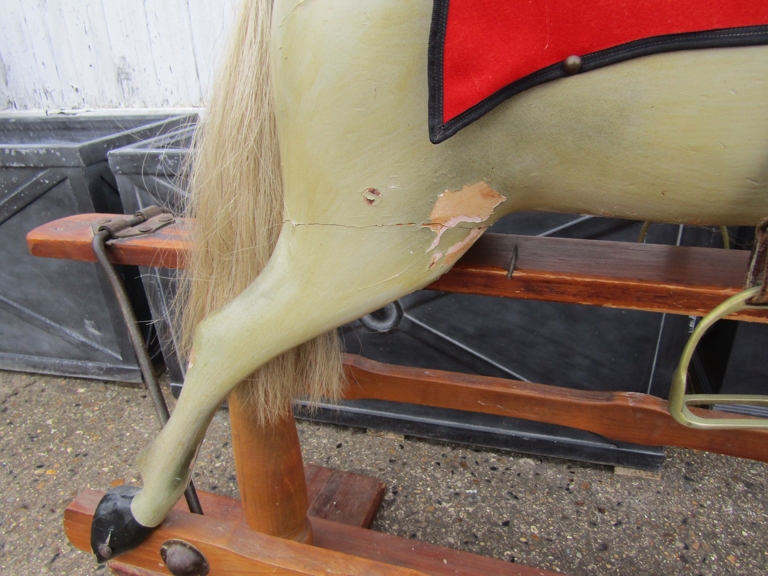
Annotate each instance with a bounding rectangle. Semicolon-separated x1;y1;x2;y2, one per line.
91;486;152;564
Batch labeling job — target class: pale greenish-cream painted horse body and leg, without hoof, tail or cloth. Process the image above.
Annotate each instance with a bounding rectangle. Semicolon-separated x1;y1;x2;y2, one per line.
100;0;768;548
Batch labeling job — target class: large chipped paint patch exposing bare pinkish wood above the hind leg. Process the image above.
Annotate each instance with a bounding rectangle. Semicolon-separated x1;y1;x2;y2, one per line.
423;182;506;250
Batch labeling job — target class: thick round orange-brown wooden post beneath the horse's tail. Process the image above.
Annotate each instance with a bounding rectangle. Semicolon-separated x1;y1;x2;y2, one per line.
229;394;312;544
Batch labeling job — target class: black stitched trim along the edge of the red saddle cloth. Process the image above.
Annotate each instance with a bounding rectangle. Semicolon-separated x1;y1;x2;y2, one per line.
428;0;768;144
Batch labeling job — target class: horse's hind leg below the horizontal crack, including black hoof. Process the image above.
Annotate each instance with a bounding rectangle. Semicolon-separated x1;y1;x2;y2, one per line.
91;218;483;561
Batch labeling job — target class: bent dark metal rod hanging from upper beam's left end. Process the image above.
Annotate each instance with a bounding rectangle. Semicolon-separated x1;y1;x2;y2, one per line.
92;227;203;514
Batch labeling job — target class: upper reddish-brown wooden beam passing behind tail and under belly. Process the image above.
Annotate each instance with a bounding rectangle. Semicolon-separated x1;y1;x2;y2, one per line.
27;214;768;322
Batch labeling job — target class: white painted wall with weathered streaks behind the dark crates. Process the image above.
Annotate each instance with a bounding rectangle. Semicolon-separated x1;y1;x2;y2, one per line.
0;0;237;111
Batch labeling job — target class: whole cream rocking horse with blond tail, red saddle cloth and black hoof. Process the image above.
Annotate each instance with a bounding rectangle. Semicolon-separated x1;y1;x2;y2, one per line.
27;0;768;572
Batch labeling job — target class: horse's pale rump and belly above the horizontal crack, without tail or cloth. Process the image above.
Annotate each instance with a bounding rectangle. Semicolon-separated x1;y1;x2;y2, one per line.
273;0;768;230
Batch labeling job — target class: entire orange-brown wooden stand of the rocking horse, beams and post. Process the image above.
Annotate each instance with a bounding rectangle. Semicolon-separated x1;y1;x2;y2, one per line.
27;214;768;576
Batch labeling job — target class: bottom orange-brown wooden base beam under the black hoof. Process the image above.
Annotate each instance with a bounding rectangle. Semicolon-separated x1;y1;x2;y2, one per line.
64;490;554;576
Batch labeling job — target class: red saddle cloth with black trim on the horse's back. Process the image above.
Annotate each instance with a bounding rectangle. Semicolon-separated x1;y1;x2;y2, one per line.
429;0;768;144
